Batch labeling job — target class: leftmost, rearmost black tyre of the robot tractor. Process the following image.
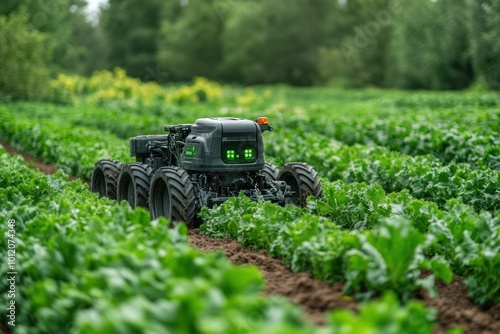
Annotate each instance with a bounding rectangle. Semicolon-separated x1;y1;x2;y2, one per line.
90;159;122;200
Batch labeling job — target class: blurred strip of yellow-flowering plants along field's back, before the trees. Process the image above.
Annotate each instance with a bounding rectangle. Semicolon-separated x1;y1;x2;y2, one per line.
49;68;500;137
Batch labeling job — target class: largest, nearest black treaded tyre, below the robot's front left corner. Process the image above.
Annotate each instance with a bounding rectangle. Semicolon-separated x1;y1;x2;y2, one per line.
149;167;197;227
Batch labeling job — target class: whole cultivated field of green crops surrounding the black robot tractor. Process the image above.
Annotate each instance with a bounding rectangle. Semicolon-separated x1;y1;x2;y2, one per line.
0;71;500;333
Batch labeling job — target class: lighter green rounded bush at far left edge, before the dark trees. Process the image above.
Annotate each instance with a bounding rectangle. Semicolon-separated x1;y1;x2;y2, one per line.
0;12;51;99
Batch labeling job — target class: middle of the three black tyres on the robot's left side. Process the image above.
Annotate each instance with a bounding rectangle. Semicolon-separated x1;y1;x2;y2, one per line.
116;162;153;209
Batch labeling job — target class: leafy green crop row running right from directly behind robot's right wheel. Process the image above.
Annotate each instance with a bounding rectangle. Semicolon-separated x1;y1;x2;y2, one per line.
265;131;500;212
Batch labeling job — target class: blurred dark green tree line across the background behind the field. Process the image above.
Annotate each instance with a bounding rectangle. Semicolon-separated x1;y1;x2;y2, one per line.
0;0;500;99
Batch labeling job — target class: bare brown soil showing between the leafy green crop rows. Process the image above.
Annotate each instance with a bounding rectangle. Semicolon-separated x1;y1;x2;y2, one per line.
0;141;500;334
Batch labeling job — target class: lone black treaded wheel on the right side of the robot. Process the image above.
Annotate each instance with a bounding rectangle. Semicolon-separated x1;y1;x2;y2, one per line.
278;162;323;207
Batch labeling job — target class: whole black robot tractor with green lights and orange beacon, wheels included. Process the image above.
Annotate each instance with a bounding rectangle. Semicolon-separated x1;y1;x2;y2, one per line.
91;117;322;226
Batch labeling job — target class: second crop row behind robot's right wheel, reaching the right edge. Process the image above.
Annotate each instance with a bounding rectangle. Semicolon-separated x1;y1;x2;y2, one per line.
302;116;500;170
